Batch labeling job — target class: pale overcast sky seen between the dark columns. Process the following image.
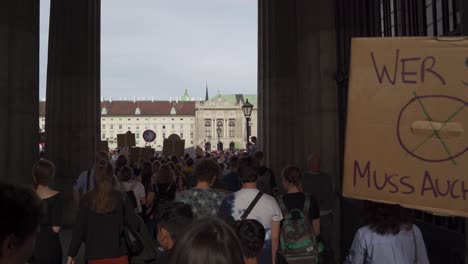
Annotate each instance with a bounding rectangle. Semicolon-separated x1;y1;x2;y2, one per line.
40;0;257;99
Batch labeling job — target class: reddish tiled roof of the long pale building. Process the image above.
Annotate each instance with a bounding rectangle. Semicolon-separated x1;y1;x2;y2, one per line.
39;101;195;116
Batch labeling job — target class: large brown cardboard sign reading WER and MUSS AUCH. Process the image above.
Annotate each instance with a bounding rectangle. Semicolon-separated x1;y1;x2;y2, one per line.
343;38;468;217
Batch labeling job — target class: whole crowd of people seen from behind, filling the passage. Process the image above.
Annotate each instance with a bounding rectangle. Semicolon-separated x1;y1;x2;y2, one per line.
0;145;429;264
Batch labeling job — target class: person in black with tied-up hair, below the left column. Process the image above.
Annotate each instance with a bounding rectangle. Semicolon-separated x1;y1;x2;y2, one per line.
32;160;63;264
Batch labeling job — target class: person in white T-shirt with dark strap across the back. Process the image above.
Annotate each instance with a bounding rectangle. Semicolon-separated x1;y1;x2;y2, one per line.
218;156;283;264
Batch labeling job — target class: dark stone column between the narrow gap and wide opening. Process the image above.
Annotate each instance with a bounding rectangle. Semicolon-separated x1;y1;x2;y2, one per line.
46;0;101;223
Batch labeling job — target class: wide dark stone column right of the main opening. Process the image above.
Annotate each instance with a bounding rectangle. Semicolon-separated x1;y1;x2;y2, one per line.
258;0;341;256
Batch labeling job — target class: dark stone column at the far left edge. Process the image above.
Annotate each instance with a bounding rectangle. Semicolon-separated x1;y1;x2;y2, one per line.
0;0;39;184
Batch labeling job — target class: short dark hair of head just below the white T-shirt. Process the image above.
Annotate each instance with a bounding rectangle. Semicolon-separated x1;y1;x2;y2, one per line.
234;219;265;258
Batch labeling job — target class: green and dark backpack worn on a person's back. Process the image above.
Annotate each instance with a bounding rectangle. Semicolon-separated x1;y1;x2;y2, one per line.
278;197;319;264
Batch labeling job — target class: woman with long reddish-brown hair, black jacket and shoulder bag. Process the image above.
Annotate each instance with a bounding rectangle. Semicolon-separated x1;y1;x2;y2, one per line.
67;160;138;264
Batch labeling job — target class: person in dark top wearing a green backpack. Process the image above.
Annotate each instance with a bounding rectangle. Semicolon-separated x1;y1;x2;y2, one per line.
278;166;320;264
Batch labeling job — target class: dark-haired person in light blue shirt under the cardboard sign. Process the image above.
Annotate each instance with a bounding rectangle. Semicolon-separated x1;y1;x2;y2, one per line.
345;202;429;264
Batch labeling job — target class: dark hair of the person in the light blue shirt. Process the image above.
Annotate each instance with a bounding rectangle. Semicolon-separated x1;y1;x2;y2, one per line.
362;201;412;235
